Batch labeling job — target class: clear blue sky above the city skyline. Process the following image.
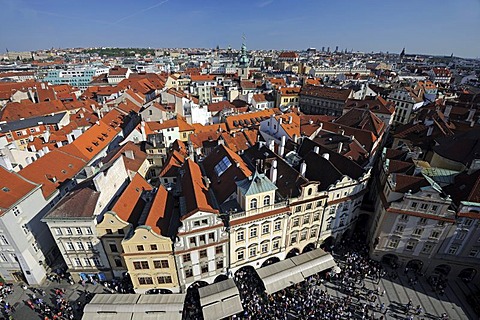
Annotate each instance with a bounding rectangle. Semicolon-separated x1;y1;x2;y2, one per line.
0;0;480;57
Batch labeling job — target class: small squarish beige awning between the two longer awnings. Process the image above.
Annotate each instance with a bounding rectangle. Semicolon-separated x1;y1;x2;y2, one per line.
198;278;243;320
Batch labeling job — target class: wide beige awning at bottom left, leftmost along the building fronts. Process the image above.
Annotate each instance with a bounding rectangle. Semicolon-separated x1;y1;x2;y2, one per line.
82;294;185;320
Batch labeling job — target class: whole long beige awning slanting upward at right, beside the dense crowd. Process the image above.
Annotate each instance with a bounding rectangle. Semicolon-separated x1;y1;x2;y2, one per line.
257;249;336;294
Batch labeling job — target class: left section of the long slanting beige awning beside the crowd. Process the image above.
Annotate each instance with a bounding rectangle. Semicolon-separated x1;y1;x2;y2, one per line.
257;259;303;294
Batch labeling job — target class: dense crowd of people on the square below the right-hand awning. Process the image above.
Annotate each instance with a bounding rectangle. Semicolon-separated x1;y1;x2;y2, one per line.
231;231;448;320
